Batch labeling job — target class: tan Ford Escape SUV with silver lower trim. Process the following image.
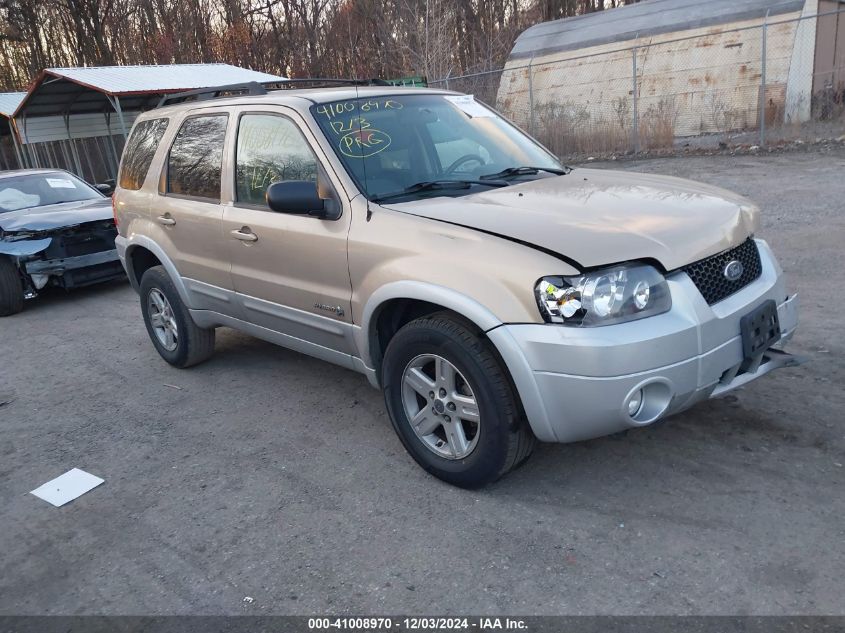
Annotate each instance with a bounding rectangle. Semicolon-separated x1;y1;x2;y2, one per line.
115;85;797;487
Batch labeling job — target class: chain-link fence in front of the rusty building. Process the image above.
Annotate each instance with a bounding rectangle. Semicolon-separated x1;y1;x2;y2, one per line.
429;7;845;156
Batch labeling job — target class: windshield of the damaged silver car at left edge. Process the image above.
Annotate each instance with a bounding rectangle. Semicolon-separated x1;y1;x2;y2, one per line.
0;171;103;213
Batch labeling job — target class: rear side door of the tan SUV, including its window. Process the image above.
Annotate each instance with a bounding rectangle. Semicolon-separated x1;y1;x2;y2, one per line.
150;109;236;314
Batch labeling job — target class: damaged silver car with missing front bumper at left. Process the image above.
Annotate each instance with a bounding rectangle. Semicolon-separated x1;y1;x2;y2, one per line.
0;169;125;316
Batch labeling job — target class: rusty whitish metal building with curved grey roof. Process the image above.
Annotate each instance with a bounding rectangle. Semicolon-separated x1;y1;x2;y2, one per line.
497;0;845;142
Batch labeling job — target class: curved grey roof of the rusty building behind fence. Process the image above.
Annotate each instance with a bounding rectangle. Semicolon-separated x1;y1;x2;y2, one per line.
510;0;804;59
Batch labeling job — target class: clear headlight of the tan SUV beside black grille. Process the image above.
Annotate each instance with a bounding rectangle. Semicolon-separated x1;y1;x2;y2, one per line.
534;264;672;326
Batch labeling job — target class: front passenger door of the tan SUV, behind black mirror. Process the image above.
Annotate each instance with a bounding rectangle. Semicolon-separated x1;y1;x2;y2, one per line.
223;110;354;362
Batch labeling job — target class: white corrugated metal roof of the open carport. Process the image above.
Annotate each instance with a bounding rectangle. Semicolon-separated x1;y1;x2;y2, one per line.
45;64;284;95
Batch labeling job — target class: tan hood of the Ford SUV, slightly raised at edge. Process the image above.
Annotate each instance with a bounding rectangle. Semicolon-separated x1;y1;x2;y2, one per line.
385;169;759;270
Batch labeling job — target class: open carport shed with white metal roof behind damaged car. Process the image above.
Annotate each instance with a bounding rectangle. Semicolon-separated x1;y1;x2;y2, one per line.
11;64;284;182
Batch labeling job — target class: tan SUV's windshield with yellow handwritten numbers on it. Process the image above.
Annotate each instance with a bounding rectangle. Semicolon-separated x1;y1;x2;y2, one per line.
311;94;563;200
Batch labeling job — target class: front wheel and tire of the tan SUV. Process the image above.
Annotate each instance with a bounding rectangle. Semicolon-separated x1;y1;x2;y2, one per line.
382;313;536;488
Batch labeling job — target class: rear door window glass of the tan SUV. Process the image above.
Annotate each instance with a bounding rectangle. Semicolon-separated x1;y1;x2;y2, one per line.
167;114;228;201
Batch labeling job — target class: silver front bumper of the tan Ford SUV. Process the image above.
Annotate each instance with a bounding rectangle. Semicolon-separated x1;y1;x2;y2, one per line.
488;240;798;442
